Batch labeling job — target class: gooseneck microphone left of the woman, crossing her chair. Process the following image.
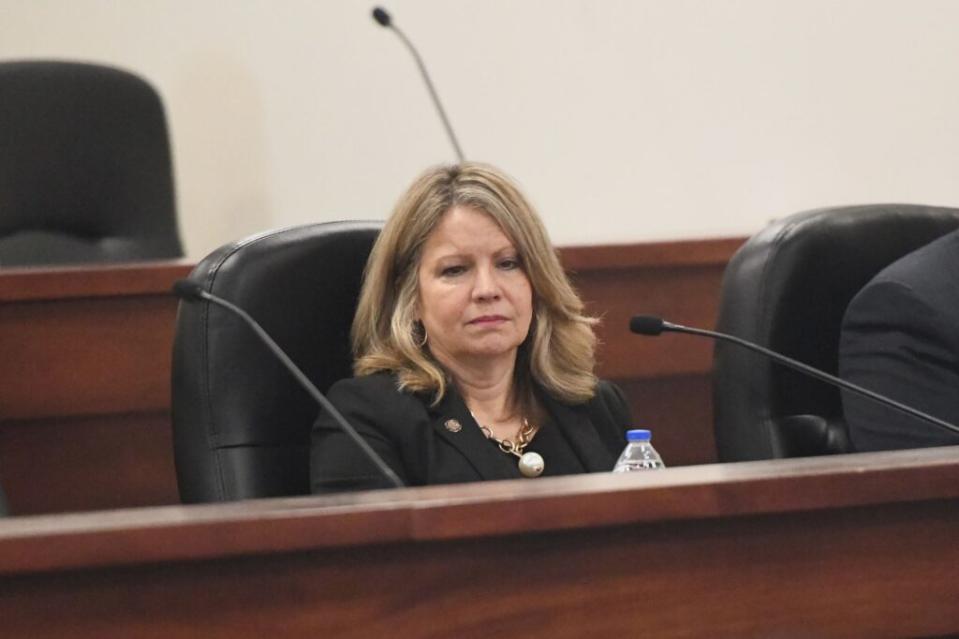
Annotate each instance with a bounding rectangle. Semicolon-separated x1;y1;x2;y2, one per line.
173;280;403;488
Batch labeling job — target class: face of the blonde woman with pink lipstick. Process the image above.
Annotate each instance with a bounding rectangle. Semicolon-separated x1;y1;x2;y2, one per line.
417;206;533;369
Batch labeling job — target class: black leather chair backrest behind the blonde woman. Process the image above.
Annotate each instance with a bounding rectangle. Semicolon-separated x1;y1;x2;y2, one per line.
172;222;382;503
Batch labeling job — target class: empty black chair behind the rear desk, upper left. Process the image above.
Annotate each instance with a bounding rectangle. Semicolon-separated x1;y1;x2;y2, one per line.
0;61;182;267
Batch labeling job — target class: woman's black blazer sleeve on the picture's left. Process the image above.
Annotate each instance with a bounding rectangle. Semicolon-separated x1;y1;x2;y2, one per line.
310;376;410;494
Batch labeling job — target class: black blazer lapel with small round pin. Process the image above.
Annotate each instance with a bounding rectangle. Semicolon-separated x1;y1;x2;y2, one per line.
428;388;515;479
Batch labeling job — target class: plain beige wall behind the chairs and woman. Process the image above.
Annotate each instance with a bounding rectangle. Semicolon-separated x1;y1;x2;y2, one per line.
0;0;959;257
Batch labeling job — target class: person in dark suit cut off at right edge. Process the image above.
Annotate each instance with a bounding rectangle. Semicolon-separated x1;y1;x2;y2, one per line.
839;231;959;451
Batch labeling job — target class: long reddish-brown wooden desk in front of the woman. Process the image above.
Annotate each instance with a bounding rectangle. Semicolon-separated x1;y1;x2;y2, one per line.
0;448;959;639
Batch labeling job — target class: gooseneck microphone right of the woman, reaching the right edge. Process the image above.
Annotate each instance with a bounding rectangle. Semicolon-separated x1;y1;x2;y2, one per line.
629;315;959;433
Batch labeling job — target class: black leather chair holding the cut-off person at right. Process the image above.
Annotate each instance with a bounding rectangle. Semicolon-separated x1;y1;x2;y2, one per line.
713;204;959;462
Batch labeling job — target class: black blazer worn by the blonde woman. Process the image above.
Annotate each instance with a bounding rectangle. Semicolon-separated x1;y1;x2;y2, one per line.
310;373;631;493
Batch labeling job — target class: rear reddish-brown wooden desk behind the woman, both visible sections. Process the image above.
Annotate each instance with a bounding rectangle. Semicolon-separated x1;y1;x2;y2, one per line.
0;239;742;514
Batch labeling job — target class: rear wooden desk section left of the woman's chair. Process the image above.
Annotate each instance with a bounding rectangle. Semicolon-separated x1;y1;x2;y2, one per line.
0;261;191;514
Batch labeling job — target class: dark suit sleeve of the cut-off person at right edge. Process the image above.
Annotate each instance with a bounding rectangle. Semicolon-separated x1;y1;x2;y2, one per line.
839;281;959;451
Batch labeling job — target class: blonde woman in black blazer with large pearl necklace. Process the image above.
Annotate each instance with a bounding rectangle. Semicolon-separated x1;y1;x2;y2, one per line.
311;163;631;493
